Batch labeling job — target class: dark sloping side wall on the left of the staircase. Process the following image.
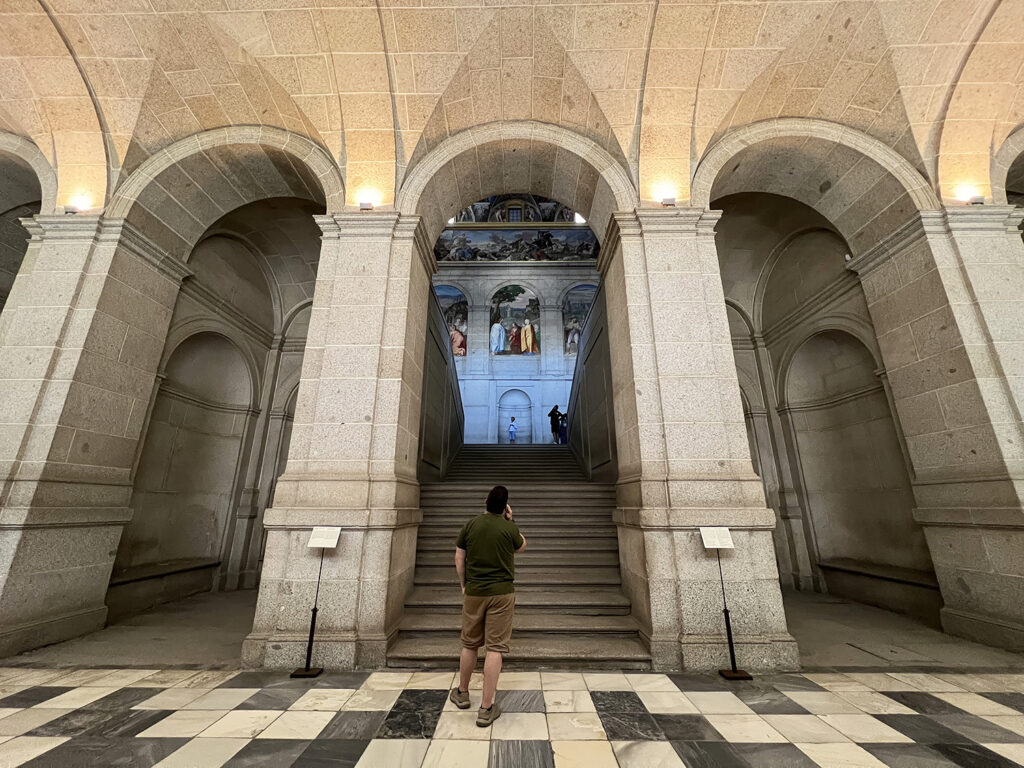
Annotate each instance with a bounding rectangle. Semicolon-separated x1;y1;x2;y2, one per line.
419;291;465;481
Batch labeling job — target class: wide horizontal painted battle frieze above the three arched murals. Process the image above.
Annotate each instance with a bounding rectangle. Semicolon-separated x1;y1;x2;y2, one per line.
434;226;600;262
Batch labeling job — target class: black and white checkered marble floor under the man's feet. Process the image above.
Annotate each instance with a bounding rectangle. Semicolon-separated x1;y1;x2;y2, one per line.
0;667;1024;768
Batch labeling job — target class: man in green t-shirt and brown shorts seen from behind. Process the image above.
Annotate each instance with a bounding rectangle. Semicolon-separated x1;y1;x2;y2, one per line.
449;485;526;728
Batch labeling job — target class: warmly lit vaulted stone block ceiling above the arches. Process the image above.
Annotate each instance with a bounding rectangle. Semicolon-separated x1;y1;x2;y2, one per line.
0;0;1024;222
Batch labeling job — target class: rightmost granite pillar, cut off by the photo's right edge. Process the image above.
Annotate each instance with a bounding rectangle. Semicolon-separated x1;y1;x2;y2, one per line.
850;206;1024;649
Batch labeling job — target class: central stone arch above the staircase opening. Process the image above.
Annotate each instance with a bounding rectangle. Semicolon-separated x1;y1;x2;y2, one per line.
395;120;639;242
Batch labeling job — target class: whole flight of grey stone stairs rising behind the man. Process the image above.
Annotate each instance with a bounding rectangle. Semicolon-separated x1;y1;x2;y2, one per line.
388;445;650;670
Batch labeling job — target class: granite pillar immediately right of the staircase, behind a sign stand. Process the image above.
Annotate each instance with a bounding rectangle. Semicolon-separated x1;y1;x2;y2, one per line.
601;208;798;670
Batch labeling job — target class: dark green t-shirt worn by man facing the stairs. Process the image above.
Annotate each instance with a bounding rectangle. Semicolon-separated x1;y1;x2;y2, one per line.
455;512;522;597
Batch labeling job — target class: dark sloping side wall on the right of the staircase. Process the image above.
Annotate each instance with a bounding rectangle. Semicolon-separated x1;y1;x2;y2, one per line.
567;285;617;482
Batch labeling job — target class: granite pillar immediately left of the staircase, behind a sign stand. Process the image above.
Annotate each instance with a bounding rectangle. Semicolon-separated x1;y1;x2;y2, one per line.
243;213;434;668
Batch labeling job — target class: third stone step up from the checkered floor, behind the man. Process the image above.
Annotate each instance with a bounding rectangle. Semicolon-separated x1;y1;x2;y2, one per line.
406;589;630;615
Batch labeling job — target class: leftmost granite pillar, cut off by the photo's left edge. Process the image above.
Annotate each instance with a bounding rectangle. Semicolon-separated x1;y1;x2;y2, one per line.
0;216;187;655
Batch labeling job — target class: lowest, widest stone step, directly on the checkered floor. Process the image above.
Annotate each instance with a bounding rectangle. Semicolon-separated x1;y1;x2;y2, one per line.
387;632;650;671
